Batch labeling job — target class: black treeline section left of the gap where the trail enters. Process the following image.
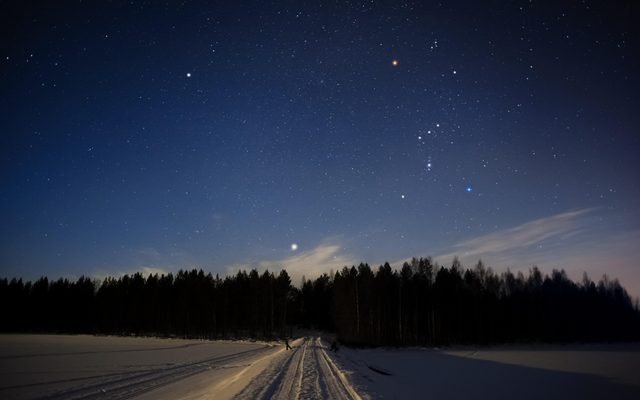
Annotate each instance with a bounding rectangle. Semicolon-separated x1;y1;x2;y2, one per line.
0;270;295;339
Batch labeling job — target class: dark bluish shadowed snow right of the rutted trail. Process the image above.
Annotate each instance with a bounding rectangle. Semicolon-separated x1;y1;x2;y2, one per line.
334;344;640;400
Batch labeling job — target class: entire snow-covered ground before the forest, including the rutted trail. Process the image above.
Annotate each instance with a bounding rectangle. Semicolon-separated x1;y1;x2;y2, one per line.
0;335;640;399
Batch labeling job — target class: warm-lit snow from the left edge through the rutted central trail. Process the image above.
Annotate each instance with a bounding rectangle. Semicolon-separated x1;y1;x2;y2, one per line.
0;335;361;400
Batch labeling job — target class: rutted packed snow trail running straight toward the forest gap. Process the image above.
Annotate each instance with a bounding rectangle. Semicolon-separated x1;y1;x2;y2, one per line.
236;337;361;400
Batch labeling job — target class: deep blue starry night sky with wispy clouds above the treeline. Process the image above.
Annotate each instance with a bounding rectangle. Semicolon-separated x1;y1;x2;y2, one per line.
0;0;640;296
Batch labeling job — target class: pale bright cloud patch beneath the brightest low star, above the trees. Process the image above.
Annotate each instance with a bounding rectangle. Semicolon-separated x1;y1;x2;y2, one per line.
227;243;359;285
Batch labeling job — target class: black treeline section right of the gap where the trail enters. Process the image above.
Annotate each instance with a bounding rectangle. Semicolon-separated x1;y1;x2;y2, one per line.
332;258;640;345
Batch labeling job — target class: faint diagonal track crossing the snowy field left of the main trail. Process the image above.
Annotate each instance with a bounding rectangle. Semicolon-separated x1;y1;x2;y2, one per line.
34;346;272;400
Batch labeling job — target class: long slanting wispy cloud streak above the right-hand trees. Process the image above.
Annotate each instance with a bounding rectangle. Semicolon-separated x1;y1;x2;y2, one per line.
435;208;594;263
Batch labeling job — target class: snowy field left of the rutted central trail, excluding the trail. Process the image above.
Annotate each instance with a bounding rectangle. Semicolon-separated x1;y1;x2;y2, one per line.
0;335;281;399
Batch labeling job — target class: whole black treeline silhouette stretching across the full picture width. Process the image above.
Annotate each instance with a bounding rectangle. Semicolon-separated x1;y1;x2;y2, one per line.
0;258;640;346
